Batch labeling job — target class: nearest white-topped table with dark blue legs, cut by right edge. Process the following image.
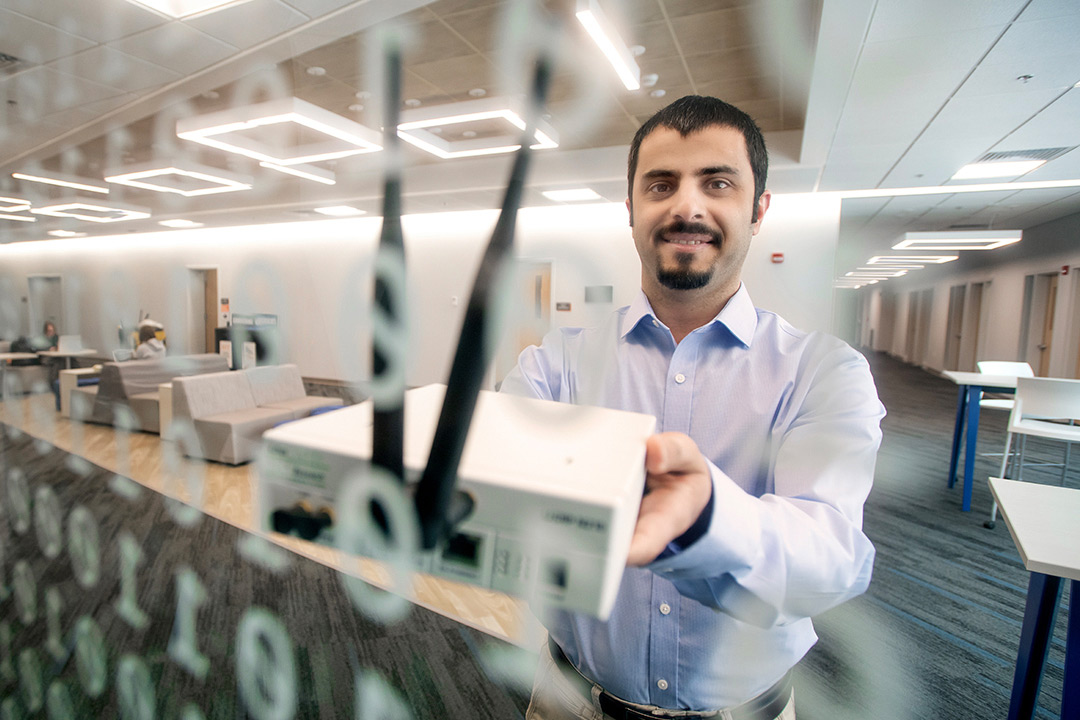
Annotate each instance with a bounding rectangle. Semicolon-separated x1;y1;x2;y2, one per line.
990;477;1080;720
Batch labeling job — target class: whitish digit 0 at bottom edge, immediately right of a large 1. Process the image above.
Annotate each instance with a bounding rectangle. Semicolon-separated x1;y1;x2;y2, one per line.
237;607;298;720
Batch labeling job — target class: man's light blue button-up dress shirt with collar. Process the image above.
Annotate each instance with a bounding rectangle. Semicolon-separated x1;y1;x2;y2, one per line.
502;287;885;710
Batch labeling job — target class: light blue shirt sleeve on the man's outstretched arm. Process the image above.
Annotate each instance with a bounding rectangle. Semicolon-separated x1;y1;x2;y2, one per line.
647;344;885;627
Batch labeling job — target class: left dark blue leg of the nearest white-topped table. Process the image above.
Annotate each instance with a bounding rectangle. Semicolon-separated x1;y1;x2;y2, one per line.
1009;572;1065;720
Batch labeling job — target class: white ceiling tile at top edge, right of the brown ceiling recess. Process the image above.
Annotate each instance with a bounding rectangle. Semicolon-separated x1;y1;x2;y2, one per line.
867;0;1027;42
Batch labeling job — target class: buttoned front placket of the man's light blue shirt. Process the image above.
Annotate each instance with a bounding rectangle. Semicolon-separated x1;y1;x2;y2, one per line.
648;332;700;707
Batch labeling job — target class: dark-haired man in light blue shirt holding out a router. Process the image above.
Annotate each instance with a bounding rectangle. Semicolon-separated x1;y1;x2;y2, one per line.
502;96;885;720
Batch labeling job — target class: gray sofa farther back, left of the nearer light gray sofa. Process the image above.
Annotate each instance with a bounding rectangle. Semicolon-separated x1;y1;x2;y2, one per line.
71;354;229;433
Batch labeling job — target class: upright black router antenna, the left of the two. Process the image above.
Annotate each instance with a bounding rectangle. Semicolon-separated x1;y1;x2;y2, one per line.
372;31;407;483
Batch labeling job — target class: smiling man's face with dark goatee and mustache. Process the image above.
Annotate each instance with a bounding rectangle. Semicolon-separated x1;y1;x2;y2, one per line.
627;126;770;301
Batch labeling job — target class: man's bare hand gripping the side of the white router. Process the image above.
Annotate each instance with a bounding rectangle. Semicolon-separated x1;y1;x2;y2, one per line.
626;433;713;566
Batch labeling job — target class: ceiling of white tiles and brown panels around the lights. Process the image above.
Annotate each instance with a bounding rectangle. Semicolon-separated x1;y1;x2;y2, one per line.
0;0;1080;280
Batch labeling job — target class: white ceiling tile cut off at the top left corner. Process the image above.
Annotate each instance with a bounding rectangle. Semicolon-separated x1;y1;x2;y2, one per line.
3;0;168;43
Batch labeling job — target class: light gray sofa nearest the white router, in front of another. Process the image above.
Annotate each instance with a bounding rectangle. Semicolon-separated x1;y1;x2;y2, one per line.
170;365;342;465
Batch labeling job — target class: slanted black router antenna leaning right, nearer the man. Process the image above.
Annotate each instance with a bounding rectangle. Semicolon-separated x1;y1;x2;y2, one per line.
416;56;551;549
